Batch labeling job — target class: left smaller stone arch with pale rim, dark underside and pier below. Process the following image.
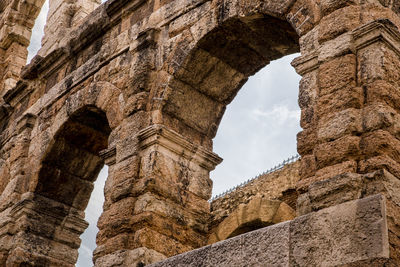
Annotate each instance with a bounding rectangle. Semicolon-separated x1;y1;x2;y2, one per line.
4;82;123;266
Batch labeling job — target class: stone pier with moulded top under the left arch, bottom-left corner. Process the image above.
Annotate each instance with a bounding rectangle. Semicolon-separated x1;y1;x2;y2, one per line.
6;192;88;267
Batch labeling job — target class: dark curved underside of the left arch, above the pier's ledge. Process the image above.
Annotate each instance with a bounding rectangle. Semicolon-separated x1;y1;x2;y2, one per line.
36;106;111;210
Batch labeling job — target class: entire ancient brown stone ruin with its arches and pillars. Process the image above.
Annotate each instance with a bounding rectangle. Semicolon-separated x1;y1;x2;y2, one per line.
0;0;400;267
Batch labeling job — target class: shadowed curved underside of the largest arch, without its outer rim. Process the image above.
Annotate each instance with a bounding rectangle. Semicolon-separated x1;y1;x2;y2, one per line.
164;14;299;137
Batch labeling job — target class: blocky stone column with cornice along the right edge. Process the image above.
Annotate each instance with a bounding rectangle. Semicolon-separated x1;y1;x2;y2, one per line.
354;20;400;266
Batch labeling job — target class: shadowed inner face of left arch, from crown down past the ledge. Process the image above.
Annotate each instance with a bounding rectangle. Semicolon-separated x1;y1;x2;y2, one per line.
34;106;111;265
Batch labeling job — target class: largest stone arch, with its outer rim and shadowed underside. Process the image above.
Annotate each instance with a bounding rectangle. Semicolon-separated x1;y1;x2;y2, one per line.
155;1;319;138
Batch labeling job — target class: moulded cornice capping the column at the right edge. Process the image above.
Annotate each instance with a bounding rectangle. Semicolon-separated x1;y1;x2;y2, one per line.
353;19;400;56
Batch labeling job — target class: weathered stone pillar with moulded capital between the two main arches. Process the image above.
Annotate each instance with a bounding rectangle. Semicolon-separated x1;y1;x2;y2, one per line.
94;125;221;266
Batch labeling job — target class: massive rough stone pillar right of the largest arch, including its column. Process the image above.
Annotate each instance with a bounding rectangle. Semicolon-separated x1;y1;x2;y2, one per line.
293;4;400;266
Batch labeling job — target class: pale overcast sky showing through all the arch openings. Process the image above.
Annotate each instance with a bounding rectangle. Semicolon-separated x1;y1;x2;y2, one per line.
28;0;300;267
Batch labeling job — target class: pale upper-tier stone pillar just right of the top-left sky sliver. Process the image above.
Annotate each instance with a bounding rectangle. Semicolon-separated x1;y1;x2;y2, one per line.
38;0;101;56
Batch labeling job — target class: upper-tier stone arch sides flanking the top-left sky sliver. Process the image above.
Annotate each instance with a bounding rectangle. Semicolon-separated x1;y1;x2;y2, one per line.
0;0;101;96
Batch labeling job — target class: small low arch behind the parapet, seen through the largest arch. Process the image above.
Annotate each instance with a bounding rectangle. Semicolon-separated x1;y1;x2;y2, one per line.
208;195;296;244
